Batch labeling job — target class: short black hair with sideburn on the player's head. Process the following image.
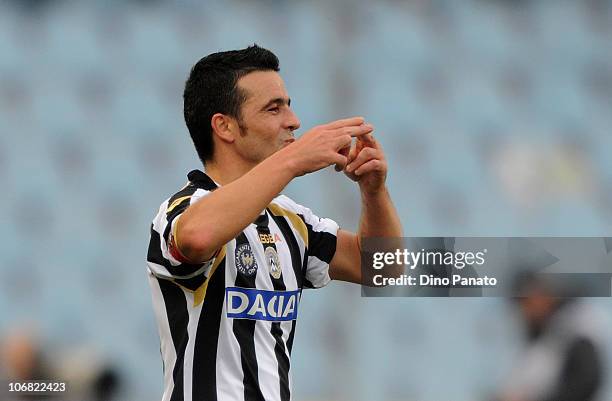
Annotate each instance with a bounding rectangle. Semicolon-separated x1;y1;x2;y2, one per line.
183;44;279;164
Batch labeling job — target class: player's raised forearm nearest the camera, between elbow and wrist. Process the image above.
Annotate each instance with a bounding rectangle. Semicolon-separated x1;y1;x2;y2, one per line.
176;152;294;261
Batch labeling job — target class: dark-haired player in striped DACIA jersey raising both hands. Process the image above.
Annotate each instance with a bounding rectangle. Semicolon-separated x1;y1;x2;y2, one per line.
147;46;401;401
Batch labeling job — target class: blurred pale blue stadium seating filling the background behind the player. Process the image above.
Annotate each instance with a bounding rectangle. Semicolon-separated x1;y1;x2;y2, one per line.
0;0;612;401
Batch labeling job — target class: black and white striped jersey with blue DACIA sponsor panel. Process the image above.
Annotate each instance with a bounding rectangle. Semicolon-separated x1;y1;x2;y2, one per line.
147;170;338;401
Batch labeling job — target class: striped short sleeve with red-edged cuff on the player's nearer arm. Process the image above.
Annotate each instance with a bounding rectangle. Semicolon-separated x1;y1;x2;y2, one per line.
147;186;214;290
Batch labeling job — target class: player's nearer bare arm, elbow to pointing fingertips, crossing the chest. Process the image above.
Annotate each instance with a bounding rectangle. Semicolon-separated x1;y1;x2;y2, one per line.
175;117;372;262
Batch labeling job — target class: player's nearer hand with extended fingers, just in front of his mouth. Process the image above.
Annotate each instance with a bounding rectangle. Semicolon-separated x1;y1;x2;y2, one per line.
282;117;374;177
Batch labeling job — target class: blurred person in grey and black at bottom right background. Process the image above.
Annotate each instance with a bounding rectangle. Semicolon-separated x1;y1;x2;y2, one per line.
496;272;605;401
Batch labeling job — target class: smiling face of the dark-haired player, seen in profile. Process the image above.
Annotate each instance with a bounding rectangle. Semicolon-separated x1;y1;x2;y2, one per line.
235;71;300;164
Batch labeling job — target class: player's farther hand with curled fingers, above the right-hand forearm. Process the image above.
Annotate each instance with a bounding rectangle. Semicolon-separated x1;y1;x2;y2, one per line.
344;134;387;194
